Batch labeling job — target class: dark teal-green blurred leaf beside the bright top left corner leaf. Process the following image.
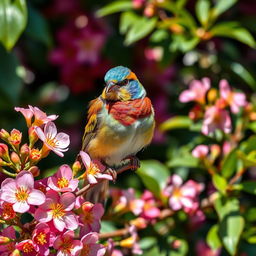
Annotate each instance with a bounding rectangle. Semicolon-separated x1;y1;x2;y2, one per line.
25;7;52;46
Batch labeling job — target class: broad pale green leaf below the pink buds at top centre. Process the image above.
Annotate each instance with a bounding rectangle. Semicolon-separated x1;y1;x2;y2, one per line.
124;17;157;45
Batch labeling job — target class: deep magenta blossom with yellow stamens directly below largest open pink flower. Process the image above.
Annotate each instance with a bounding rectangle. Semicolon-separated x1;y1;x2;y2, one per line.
32;223;51;256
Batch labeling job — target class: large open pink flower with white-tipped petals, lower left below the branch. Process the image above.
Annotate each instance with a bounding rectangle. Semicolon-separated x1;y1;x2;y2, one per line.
34;190;78;231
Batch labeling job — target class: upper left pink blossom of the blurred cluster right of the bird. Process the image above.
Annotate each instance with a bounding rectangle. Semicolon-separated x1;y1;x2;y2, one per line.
179;77;211;104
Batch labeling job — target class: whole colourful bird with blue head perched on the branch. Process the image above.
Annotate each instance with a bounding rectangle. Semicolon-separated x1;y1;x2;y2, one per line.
82;66;155;203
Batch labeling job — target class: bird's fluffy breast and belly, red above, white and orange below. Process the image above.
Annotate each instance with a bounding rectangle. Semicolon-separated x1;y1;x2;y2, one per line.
88;97;155;165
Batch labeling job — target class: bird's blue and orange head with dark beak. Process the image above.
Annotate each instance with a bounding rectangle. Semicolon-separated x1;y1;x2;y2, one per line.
102;66;146;101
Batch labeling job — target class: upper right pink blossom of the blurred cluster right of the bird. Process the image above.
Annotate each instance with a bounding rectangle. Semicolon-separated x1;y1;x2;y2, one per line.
219;79;247;114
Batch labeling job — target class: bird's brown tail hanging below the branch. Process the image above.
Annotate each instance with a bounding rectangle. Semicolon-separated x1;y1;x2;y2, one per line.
85;180;109;204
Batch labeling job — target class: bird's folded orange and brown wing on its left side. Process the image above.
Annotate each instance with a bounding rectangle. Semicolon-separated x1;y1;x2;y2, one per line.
82;97;104;151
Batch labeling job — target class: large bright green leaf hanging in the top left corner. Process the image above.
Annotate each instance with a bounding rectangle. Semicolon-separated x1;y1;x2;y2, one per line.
0;0;27;50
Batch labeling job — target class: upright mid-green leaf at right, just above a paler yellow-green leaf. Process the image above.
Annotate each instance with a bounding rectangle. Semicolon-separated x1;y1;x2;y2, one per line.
221;149;238;178
